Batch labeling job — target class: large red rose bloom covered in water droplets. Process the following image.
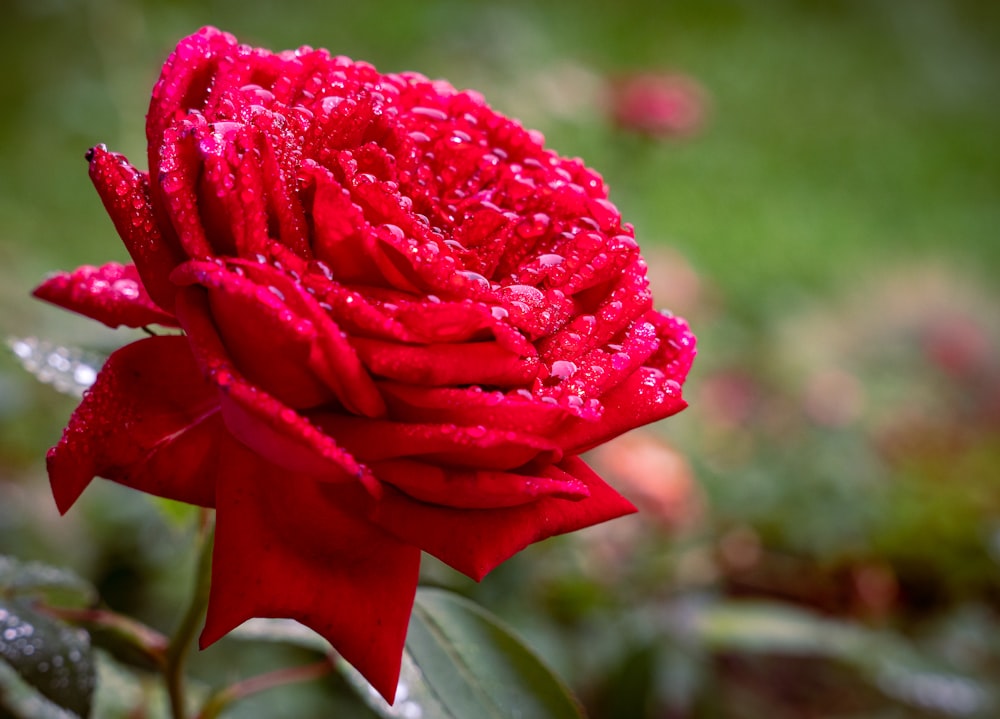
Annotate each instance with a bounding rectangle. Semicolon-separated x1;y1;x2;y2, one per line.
36;28;695;700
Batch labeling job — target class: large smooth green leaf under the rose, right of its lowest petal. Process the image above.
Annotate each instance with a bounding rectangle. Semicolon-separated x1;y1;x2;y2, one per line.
349;588;582;719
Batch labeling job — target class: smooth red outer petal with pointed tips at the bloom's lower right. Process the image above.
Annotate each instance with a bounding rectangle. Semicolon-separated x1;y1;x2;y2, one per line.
372;457;636;581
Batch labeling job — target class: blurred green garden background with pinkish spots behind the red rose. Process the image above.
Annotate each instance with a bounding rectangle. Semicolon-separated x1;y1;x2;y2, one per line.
0;0;1000;719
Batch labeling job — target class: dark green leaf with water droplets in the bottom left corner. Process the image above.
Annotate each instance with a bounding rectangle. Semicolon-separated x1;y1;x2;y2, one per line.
0;599;95;719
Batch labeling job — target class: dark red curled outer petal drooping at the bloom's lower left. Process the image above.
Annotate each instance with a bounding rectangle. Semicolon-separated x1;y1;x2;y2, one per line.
48;336;226;512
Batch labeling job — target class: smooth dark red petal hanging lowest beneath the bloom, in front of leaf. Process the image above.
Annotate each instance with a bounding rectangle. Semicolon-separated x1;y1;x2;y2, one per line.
201;462;420;701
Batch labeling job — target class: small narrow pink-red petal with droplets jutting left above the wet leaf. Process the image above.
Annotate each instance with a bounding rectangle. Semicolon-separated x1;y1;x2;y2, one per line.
33;262;177;327
